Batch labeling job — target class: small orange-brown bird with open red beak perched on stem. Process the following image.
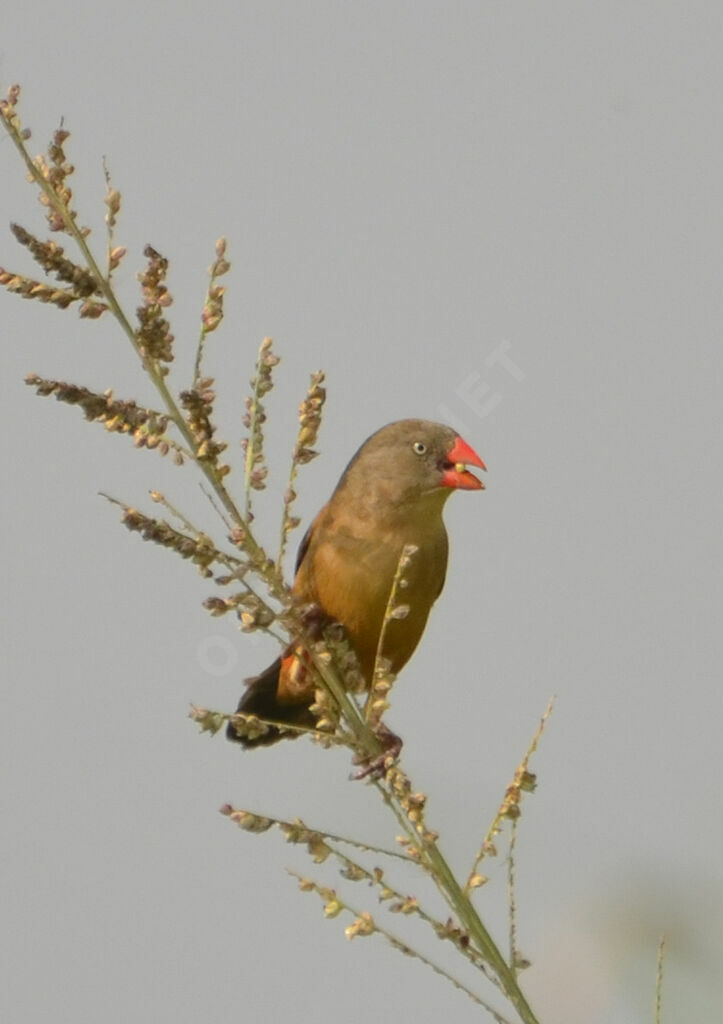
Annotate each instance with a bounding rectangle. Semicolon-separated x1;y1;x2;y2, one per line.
226;420;486;746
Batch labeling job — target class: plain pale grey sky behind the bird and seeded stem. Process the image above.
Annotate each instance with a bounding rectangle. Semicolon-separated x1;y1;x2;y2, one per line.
0;0;723;1024
